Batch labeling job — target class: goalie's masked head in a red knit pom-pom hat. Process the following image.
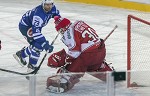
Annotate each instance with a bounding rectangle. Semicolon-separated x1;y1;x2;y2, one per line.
54;16;71;34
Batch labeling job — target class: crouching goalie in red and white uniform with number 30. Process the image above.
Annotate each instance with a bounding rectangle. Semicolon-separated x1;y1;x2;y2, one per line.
47;17;113;93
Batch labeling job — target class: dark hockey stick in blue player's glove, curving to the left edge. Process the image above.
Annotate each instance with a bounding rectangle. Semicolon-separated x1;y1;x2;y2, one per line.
0;33;59;75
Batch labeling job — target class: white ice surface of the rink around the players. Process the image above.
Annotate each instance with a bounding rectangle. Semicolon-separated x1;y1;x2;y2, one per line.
0;0;149;96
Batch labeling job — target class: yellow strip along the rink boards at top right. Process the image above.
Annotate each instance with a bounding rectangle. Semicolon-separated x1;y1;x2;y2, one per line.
65;0;150;12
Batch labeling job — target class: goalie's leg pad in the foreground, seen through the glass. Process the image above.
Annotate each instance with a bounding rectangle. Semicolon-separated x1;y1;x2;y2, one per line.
47;75;79;93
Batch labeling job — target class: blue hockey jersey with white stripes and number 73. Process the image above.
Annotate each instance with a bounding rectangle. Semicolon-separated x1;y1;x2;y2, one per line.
20;5;60;42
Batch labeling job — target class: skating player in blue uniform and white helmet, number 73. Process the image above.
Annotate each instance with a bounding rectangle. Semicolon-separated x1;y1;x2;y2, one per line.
13;0;60;72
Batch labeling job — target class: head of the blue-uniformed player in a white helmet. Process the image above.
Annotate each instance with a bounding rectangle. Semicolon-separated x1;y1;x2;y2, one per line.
42;0;54;12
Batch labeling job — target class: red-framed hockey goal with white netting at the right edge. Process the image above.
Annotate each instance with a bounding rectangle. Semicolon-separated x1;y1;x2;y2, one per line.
127;15;150;87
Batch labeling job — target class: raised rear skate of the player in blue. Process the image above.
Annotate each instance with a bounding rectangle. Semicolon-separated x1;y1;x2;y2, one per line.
13;51;27;67
